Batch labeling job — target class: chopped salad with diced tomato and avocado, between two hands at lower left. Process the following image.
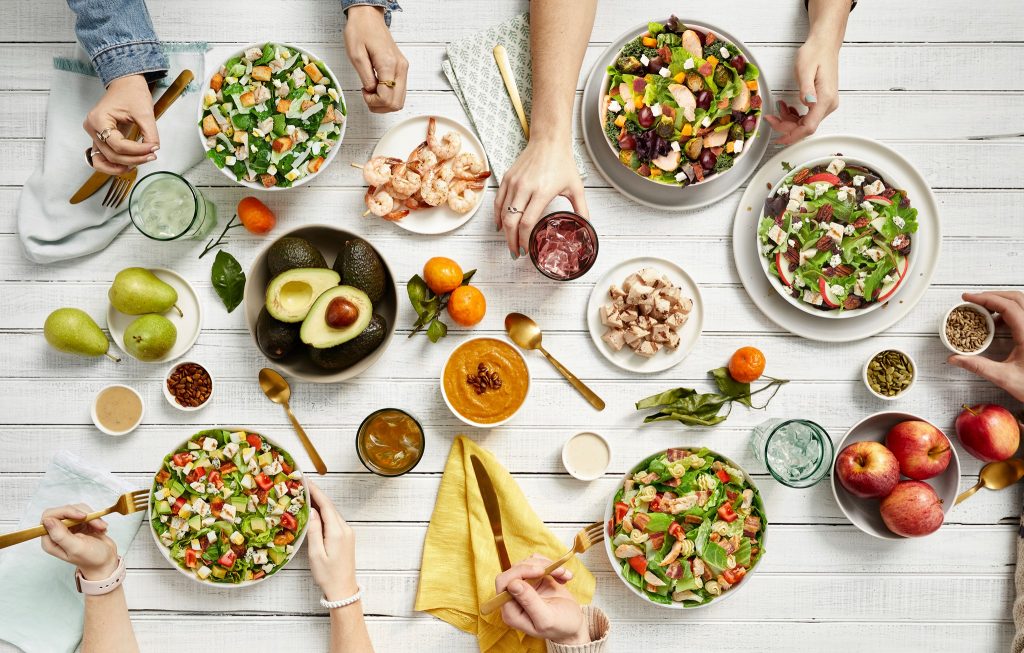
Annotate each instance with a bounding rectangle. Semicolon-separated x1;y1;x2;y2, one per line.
150;430;309;583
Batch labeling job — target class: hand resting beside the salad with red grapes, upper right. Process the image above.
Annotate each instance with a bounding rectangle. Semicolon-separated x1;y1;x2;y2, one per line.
765;36;842;145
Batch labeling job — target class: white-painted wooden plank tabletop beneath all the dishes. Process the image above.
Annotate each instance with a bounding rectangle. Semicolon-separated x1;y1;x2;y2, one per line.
0;0;1024;652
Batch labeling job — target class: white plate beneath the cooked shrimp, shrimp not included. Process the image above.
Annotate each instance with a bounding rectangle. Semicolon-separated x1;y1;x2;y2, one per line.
367;116;490;234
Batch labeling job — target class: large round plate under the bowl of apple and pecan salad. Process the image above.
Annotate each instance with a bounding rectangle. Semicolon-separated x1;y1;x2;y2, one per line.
732;135;942;342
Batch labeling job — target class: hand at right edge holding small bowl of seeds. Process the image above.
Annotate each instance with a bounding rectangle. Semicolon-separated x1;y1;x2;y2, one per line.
949;291;1024;401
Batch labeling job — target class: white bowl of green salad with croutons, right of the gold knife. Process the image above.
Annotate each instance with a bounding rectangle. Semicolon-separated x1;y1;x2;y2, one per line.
199;42;347;190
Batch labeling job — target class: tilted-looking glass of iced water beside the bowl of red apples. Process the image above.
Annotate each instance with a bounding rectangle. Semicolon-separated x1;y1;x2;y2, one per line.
751;420;833;488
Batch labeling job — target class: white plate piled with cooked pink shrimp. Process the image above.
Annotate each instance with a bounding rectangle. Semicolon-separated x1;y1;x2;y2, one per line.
353;116;490;233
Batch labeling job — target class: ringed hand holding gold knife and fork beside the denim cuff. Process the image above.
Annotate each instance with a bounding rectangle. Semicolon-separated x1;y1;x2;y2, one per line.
82;75;160;175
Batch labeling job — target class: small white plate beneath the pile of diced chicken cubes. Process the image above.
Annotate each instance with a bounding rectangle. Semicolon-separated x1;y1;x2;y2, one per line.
587;256;703;374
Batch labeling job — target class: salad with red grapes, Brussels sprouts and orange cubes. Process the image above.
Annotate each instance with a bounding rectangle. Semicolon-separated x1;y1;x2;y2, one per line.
601;16;762;186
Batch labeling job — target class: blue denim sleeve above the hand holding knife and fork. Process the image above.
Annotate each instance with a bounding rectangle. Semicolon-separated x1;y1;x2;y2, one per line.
68;0;168;86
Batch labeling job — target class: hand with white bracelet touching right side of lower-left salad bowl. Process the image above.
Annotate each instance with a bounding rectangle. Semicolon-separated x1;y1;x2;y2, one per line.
306;480;359;601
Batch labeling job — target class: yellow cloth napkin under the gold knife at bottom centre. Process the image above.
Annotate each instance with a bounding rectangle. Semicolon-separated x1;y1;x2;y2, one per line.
416;435;594;653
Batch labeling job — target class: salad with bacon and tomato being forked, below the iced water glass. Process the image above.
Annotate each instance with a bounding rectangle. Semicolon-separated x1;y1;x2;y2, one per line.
608;448;767;608
